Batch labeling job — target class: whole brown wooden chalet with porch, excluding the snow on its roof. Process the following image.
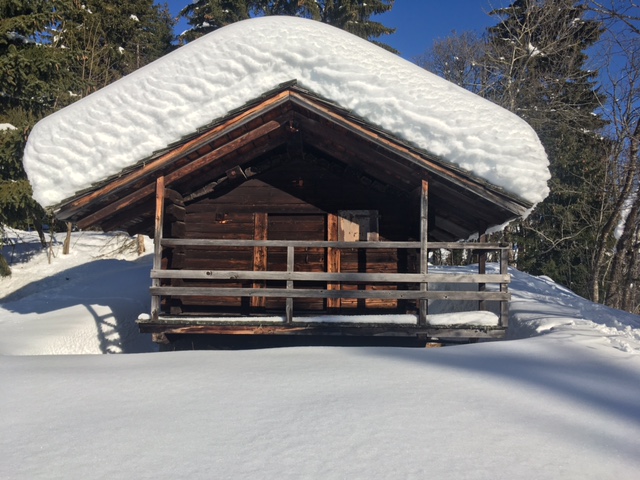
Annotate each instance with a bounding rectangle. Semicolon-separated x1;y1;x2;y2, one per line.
52;81;531;341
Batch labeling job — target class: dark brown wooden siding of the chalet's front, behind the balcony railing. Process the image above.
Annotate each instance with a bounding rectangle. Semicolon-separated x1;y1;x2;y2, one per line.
158;171;417;315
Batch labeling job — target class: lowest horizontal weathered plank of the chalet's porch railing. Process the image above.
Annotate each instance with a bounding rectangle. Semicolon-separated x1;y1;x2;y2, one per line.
151;287;510;301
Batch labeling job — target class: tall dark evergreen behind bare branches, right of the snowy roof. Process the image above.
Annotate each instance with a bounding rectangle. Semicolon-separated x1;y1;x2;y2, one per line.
486;0;608;296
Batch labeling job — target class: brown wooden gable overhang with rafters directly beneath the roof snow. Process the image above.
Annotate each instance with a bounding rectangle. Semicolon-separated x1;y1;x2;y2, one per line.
55;81;532;241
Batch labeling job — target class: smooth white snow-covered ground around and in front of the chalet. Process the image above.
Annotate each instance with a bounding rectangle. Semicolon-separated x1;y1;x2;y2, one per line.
0;232;640;479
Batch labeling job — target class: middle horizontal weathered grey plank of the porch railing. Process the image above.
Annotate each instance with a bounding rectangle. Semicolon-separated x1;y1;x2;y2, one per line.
151;269;511;283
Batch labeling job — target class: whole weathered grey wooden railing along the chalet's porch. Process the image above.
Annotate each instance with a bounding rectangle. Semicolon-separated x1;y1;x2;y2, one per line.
151;239;510;327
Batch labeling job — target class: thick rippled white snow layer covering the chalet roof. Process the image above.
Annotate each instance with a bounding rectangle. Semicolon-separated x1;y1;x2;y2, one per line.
24;17;549;206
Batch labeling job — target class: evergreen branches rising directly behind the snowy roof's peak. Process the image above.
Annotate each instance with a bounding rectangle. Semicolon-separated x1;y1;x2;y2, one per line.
180;0;395;51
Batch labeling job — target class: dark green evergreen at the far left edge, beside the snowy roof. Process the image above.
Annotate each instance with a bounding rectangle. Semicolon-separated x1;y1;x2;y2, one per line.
0;0;80;253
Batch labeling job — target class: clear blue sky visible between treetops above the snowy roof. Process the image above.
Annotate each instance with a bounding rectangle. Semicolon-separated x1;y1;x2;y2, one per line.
160;0;509;60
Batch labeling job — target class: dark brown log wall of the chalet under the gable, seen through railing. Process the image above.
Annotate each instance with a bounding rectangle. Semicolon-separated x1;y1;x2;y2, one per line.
163;172;417;315
